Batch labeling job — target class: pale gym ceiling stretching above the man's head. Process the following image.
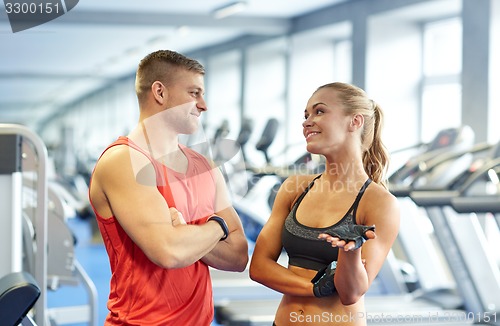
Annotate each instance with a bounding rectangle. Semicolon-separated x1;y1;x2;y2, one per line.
0;0;347;130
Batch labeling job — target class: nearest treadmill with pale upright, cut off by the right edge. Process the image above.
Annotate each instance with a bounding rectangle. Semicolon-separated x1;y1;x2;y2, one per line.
410;143;500;325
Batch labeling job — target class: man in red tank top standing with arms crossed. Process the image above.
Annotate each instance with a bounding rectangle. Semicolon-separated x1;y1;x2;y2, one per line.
89;51;248;326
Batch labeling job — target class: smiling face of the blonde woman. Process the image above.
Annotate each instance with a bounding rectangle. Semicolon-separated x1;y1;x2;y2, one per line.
302;88;351;155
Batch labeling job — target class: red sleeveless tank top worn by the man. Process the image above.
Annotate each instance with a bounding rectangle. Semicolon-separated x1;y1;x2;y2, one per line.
90;137;216;326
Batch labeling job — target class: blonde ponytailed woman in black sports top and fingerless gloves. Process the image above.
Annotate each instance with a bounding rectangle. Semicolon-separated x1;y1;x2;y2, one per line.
250;83;399;326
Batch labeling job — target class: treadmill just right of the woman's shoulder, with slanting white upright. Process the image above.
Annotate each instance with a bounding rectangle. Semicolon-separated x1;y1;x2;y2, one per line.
389;126;484;309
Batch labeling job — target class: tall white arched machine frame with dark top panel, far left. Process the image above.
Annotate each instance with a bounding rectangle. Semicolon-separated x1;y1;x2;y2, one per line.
0;124;50;325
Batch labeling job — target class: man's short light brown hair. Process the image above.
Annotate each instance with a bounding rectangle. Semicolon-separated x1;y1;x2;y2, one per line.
135;50;205;101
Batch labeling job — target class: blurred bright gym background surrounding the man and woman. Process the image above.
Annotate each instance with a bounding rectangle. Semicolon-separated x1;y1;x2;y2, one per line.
0;0;500;326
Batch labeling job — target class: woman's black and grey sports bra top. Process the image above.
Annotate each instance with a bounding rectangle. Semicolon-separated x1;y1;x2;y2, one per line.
281;175;372;270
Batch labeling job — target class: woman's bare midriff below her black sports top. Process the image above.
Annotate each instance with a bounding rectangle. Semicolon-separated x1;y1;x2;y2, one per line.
275;266;366;326
